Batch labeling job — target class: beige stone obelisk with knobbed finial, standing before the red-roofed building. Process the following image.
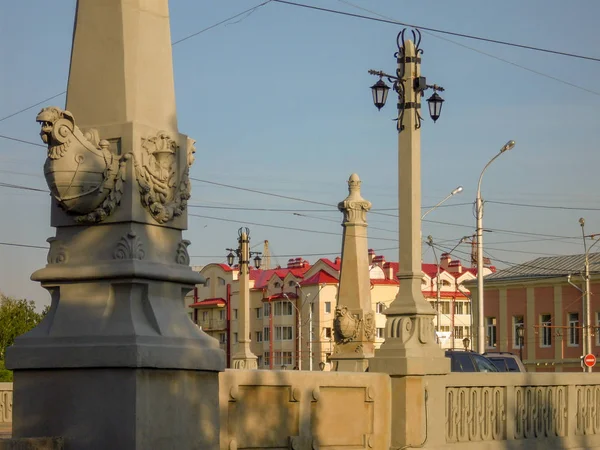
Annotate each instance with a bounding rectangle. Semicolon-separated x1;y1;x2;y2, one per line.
331;173;375;372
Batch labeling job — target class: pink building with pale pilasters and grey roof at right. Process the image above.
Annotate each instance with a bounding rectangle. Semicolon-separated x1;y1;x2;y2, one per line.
465;253;600;372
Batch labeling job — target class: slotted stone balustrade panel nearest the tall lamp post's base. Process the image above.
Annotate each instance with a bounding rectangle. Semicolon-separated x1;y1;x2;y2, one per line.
446;387;506;442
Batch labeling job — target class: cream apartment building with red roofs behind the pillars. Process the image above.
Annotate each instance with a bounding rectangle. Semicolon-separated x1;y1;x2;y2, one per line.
186;250;492;370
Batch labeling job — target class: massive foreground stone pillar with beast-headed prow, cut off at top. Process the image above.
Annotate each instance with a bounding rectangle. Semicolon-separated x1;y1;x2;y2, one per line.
7;0;225;450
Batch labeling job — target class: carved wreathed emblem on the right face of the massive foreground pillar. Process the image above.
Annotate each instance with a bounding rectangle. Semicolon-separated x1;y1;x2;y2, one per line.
133;131;196;223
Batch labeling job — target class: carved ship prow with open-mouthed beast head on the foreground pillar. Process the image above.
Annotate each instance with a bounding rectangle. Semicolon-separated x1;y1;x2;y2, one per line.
36;106;125;223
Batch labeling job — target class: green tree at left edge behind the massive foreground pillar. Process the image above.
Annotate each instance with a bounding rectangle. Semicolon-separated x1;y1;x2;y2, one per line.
0;293;48;362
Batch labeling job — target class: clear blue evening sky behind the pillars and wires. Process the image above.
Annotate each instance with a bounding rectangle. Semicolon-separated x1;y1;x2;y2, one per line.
0;0;600;305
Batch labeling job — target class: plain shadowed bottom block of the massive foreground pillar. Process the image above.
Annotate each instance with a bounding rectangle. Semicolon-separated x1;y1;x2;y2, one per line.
9;368;219;450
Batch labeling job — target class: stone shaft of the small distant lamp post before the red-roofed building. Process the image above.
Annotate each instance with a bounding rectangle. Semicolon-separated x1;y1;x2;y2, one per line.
227;228;258;369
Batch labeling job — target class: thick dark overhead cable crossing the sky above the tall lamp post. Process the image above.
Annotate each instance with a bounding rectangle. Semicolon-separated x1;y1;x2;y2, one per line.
272;0;600;62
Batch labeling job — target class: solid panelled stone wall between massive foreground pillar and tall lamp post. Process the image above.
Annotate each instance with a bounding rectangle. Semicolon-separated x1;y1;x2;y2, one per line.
219;370;391;450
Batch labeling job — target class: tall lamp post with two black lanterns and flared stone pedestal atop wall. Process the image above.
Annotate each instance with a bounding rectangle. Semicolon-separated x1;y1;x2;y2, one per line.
369;30;449;382
